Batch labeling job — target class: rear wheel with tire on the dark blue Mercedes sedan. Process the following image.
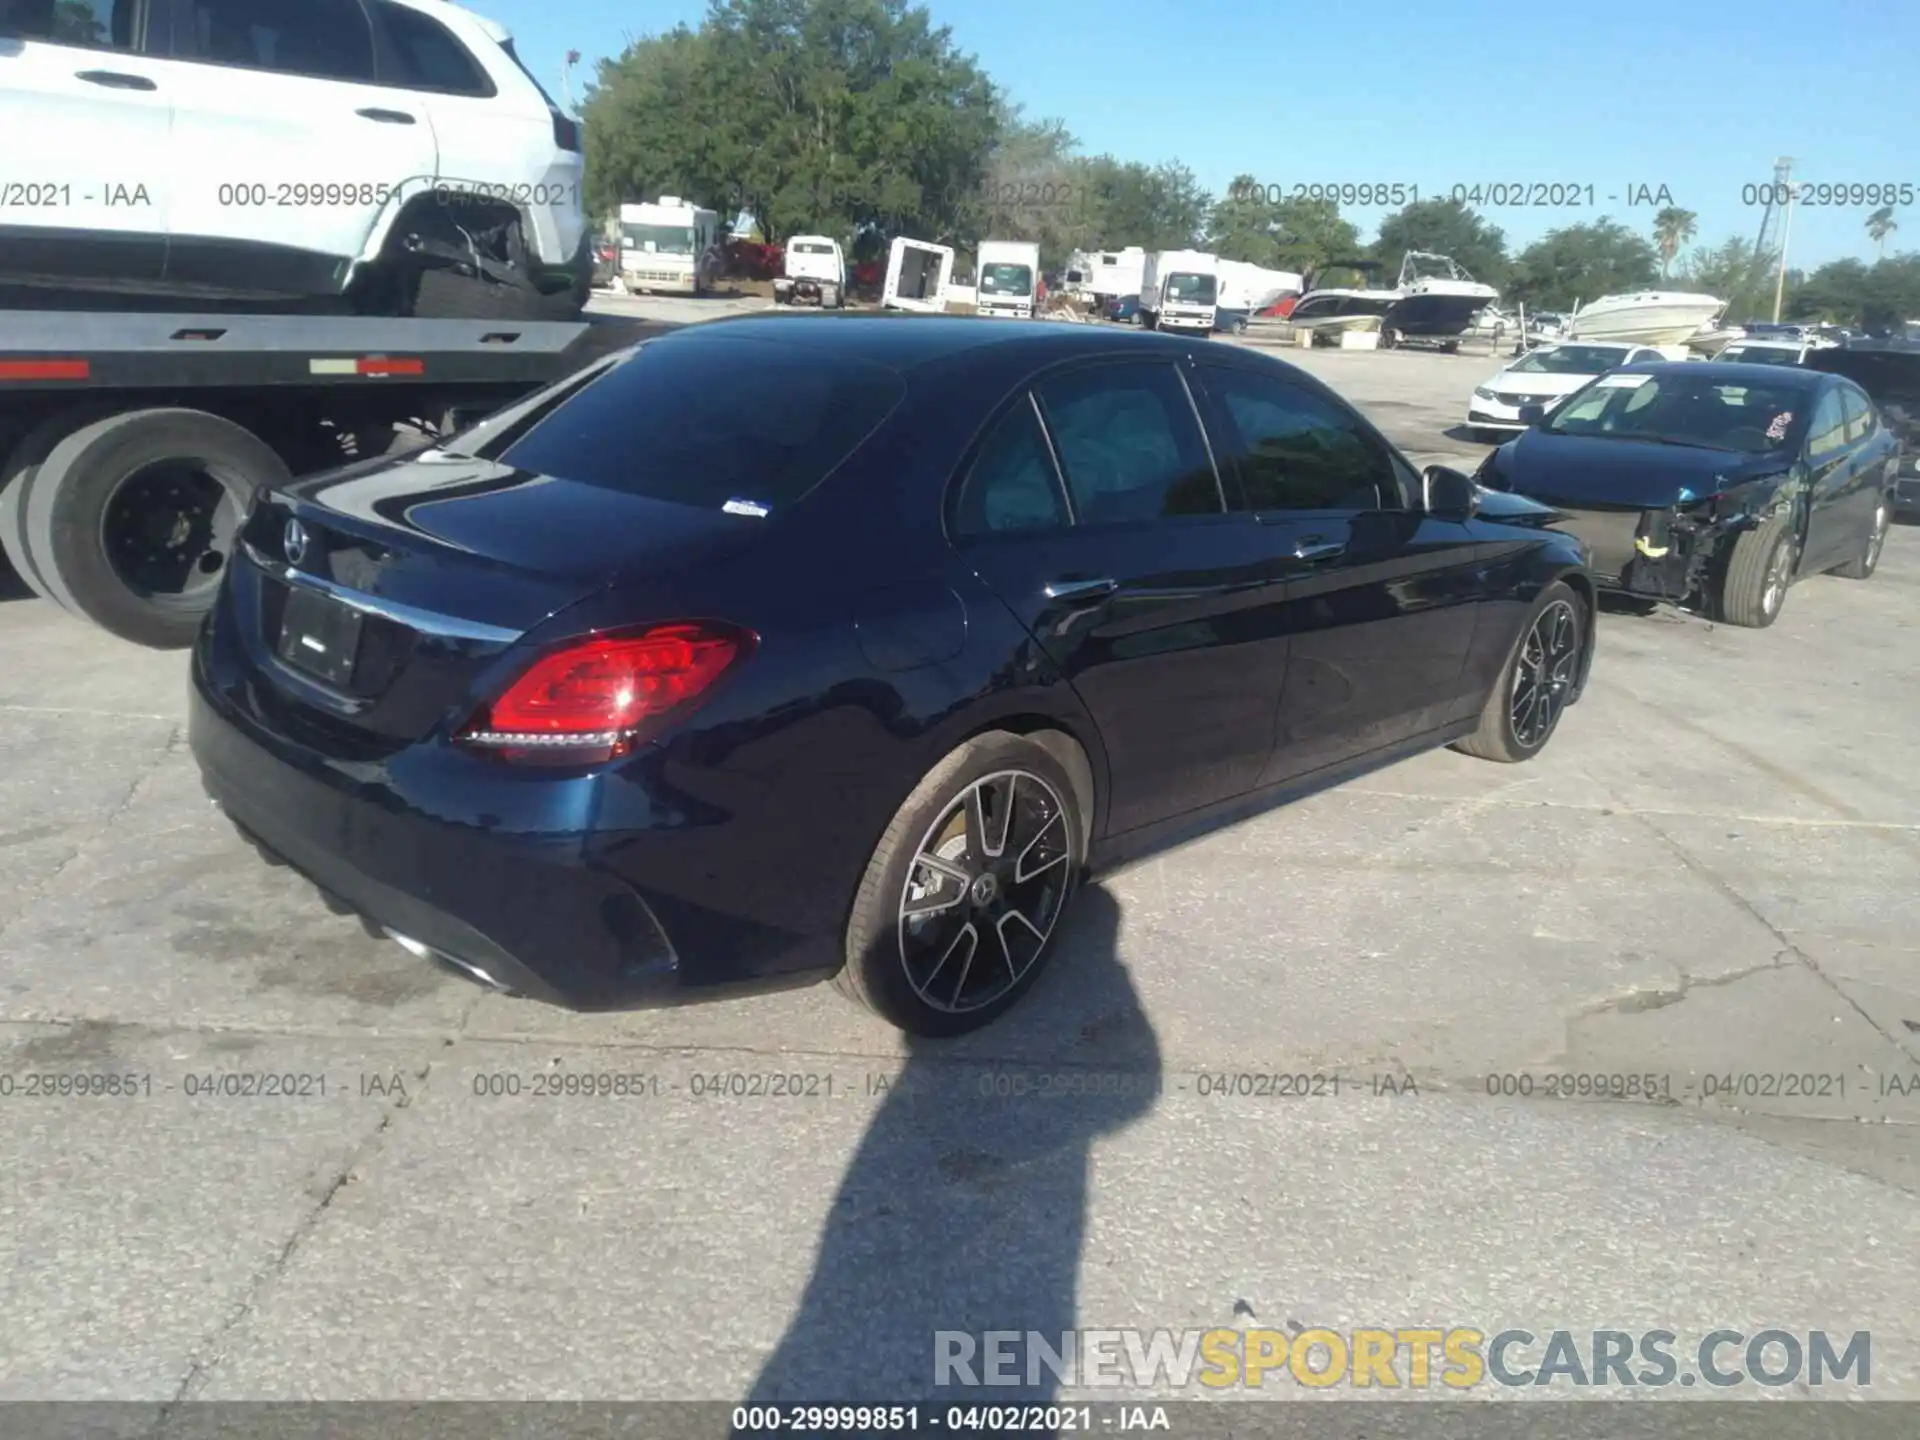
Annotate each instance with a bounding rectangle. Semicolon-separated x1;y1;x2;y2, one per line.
835;732;1087;1037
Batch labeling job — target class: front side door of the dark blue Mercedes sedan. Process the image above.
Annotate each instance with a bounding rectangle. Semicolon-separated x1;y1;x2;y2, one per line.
1200;363;1482;783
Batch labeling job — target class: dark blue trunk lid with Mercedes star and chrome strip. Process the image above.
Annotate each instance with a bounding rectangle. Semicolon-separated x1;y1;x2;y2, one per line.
230;455;764;755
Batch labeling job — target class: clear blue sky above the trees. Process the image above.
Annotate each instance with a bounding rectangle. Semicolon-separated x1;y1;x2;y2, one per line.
491;0;1920;269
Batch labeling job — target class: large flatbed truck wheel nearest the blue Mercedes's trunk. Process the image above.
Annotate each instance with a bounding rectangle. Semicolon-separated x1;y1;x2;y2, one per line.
23;409;292;649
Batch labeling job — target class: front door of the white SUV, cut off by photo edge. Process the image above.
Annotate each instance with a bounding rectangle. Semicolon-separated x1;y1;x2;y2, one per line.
0;0;180;284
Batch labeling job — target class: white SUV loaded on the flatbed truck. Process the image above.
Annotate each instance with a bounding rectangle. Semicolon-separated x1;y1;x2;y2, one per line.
0;0;591;319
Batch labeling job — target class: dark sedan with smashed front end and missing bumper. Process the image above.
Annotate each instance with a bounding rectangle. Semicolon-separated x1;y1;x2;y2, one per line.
1475;361;1899;628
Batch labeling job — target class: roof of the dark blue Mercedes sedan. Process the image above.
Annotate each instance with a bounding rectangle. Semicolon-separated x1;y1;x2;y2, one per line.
649;313;1190;372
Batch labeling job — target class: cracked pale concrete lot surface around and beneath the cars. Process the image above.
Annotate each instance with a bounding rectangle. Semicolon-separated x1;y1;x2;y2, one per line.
0;314;1920;1402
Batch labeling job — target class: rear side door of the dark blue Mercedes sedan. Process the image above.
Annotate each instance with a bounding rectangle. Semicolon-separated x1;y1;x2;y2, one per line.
950;359;1286;833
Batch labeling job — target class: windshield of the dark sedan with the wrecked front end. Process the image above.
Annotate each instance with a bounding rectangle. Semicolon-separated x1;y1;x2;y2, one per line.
1546;367;1803;455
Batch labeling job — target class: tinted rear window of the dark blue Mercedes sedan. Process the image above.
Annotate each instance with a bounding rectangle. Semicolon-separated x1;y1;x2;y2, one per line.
488;336;904;515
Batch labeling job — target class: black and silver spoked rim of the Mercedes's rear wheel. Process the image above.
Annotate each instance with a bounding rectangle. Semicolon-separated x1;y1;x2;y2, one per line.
899;770;1073;1014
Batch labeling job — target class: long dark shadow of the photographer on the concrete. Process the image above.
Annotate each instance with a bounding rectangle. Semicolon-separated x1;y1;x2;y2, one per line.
747;883;1160;1405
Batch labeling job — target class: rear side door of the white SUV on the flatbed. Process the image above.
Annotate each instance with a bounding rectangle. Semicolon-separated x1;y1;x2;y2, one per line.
167;0;438;296
